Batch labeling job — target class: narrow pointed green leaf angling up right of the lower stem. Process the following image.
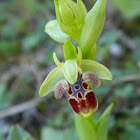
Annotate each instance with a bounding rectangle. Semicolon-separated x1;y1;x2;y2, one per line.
95;104;113;140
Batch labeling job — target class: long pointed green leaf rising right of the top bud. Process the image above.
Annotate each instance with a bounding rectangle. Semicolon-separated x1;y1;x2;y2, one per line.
79;0;106;58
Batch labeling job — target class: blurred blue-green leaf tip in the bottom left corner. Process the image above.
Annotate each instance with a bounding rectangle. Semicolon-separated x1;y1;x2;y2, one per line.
7;125;33;140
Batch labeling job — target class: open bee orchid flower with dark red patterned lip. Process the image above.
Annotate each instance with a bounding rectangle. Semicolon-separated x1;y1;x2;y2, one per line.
40;41;112;117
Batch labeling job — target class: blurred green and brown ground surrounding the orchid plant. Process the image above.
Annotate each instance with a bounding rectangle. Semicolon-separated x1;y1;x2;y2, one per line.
0;0;140;140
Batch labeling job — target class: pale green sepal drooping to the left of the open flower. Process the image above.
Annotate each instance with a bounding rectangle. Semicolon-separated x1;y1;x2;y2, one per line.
39;67;64;97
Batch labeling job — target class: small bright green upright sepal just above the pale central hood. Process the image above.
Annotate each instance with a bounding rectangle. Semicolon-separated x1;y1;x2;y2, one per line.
63;41;77;61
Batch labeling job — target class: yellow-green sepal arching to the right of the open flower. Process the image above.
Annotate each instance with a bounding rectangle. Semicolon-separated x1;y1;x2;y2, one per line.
80;59;112;80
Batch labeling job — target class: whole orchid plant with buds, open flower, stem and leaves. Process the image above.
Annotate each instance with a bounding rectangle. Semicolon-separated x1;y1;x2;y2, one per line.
39;0;113;140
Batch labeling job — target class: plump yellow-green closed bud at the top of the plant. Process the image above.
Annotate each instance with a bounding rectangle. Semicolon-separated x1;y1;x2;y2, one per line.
54;0;87;41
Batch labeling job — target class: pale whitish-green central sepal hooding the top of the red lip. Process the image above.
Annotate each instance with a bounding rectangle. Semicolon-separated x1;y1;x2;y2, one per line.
62;60;78;85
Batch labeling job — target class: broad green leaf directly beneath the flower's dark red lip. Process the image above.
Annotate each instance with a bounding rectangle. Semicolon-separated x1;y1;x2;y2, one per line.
75;115;98;140
